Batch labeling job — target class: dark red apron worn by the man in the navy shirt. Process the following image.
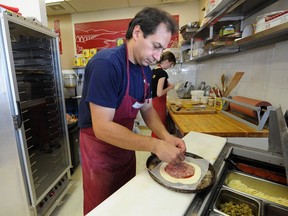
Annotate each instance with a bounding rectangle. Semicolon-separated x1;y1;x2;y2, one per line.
80;45;148;215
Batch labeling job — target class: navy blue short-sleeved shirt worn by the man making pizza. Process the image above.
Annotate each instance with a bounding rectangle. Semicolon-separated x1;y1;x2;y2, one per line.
78;44;152;128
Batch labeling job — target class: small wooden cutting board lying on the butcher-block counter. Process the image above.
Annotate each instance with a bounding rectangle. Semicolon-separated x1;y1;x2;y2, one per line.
170;105;216;115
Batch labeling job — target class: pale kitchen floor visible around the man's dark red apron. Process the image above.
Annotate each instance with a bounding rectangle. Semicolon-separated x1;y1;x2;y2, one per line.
51;127;151;216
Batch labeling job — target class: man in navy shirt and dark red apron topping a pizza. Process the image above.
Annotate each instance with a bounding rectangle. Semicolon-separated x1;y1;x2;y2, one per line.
78;7;186;214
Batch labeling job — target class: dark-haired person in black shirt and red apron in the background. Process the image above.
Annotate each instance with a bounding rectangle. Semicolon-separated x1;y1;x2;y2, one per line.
151;51;176;138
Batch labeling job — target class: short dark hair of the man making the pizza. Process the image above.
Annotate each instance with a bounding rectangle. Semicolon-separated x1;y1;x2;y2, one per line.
126;7;178;40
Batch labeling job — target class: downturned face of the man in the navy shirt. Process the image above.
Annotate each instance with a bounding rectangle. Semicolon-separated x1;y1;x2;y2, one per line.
133;23;171;66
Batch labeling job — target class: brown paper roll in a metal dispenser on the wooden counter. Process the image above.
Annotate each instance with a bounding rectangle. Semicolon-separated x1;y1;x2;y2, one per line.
230;96;271;118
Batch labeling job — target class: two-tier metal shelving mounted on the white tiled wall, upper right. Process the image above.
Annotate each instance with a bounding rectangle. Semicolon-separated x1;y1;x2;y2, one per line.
188;0;280;61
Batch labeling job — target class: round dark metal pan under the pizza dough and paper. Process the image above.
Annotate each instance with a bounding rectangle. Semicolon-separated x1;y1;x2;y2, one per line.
146;152;216;193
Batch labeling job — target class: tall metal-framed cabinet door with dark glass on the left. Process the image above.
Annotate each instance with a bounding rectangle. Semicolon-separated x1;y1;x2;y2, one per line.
0;8;71;215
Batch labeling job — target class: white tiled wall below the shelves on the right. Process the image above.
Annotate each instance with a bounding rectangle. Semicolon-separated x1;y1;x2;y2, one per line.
196;41;288;112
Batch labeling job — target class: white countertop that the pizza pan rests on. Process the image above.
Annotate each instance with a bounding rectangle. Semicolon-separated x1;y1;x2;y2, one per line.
88;132;227;216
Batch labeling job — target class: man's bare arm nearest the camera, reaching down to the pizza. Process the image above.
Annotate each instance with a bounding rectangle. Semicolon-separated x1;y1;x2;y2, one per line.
90;103;186;162
